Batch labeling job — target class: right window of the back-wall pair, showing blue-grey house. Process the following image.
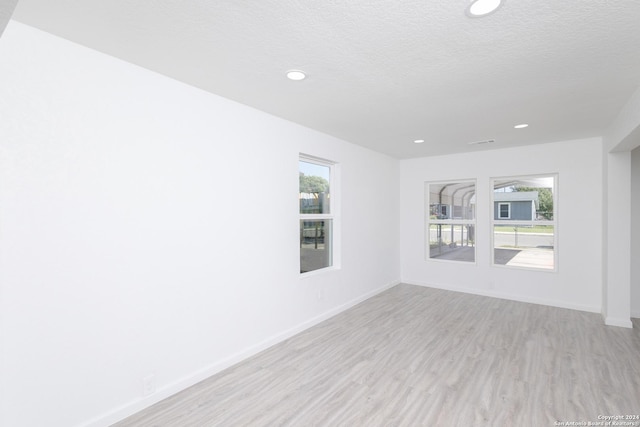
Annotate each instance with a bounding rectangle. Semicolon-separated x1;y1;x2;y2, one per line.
492;175;557;271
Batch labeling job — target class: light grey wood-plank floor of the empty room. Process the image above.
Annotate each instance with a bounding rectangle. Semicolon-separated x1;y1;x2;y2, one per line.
116;285;640;427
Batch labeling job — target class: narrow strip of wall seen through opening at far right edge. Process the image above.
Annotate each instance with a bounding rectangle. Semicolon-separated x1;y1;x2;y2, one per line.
631;147;640;318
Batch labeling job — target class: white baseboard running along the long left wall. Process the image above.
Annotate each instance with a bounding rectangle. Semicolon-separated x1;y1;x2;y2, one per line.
82;280;400;427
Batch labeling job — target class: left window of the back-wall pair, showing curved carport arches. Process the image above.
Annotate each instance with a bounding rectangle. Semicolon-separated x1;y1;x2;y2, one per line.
425;181;476;262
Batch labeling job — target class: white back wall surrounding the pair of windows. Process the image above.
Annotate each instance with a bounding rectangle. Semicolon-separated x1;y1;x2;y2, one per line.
400;138;603;312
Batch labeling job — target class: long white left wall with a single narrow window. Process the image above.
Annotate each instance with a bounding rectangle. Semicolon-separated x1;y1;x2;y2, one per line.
0;22;400;427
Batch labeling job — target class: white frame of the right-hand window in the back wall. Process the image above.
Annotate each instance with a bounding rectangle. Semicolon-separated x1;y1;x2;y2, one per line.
489;172;559;273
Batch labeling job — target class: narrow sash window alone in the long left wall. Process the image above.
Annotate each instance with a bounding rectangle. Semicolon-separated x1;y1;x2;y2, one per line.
299;156;334;273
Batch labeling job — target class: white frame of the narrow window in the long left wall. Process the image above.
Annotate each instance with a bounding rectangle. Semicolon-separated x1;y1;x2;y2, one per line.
298;153;340;278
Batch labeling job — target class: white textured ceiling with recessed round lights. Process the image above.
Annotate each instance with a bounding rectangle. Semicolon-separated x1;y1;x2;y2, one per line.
7;0;640;158
